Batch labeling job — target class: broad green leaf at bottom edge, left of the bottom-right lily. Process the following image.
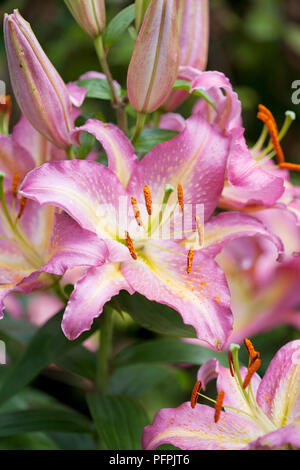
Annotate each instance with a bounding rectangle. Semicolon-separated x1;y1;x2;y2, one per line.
87;394;149;450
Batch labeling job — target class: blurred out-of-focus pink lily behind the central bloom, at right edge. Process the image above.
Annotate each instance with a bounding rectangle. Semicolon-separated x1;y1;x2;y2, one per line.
217;237;300;346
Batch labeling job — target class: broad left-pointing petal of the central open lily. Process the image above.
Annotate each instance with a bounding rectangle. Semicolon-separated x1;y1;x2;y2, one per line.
21;160;126;238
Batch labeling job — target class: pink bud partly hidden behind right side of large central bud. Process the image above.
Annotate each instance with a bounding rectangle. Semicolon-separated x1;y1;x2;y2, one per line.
163;0;209;111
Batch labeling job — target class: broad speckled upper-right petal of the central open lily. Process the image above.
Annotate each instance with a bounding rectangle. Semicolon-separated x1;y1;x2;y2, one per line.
128;115;229;220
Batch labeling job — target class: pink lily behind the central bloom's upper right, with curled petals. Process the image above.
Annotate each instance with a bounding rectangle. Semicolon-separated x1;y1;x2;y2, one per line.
162;67;290;210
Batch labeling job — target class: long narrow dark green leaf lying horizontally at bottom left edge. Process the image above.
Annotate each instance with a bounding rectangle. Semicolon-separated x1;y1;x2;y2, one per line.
0;408;94;437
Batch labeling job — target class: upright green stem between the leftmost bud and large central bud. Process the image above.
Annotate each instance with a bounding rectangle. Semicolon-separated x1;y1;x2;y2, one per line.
94;34;128;135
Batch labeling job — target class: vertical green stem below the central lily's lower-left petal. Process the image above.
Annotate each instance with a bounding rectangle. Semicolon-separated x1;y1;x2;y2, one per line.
96;307;113;394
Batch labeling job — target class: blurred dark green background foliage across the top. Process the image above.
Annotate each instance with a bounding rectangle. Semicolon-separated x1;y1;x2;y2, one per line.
0;0;300;163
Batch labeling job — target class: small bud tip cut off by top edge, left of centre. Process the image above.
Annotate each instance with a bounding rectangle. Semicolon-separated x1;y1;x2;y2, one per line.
65;0;105;38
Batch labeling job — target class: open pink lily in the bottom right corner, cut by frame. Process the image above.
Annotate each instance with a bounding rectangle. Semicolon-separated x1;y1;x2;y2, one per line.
142;340;300;450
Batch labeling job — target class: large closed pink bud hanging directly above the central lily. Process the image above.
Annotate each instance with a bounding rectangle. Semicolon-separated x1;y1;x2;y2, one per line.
127;0;179;113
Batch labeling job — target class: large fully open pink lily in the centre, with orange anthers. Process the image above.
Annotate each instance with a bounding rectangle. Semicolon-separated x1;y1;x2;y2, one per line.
21;116;281;349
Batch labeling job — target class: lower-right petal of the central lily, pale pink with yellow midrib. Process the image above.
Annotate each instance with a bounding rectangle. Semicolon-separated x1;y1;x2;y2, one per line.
122;240;232;350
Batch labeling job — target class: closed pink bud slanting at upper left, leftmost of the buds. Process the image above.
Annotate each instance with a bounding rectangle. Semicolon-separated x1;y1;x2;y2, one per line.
4;10;74;149
